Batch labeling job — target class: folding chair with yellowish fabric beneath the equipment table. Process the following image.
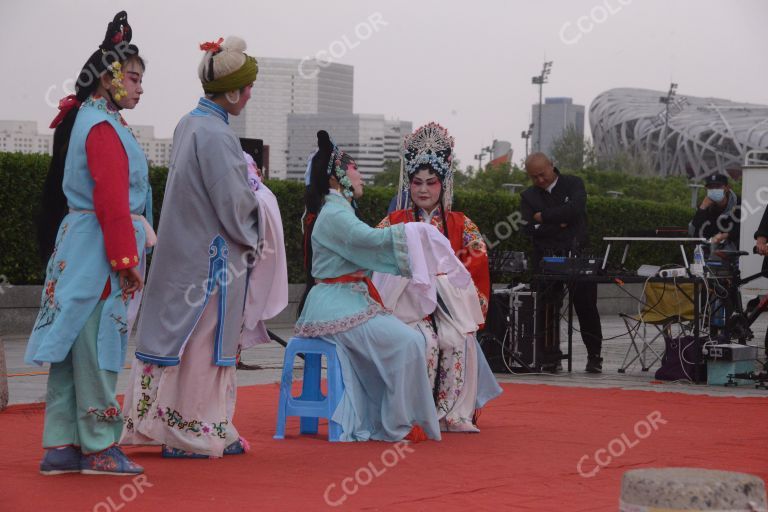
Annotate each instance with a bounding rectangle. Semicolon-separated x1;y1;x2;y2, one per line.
619;281;694;373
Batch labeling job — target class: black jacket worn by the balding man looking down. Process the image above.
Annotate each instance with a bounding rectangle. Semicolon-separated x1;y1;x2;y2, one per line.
520;172;589;259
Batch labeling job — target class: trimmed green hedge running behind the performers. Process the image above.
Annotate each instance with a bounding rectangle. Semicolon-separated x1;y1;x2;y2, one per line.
0;153;692;284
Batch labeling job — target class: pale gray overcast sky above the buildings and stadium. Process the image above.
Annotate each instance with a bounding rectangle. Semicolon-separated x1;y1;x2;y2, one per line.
0;0;768;165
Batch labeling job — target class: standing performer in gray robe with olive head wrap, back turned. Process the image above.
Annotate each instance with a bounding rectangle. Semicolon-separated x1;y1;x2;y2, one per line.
120;37;259;458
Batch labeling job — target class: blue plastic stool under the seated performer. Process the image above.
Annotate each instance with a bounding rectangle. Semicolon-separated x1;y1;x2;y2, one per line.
274;338;344;441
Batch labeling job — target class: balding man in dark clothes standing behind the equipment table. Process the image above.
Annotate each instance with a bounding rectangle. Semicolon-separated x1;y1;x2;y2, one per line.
520;153;603;373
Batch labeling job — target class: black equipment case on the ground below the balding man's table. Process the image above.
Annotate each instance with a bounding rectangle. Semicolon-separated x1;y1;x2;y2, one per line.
478;289;560;372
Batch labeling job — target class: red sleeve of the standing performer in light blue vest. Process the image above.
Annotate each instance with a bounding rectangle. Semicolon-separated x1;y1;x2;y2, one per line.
85;122;139;270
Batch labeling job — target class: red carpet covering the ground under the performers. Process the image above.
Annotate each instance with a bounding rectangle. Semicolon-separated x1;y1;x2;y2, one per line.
0;384;768;512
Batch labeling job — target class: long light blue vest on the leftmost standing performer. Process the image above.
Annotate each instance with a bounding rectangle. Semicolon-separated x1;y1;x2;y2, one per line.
24;98;152;372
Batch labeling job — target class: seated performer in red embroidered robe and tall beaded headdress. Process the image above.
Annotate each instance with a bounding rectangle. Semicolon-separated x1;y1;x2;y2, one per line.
379;123;501;432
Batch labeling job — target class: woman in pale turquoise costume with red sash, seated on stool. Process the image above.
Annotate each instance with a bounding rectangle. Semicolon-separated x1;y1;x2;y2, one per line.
296;131;440;441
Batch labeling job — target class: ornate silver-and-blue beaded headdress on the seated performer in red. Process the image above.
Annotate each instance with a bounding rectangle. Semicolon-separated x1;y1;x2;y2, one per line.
397;122;453;210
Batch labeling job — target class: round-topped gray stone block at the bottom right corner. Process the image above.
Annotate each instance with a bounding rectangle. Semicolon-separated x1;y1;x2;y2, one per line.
620;468;766;512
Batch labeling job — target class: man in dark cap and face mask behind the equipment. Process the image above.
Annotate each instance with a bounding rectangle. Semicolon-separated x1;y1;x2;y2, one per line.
688;172;741;249
